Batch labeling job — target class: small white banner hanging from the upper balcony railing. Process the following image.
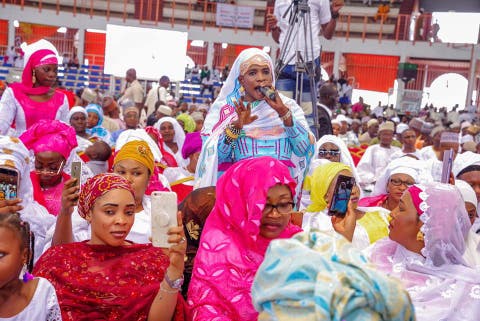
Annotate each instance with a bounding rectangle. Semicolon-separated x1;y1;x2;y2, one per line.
217;3;255;29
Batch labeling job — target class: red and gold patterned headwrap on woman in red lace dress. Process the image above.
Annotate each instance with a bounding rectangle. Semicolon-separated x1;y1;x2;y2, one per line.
78;173;135;218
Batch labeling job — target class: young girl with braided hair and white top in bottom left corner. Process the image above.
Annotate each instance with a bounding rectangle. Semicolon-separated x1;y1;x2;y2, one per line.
0;214;62;321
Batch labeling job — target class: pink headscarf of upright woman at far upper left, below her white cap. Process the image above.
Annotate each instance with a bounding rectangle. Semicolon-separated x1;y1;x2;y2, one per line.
10;49;58;95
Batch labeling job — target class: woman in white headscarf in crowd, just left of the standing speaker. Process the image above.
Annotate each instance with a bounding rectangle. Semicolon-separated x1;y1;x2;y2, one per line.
154;117;185;167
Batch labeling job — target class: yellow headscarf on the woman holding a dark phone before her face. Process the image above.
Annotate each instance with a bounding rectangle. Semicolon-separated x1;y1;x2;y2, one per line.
303;162;352;212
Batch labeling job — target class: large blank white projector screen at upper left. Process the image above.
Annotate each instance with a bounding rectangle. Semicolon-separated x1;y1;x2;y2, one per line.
105;24;187;81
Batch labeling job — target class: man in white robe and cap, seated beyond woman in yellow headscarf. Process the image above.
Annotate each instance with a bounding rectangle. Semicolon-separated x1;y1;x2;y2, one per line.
357;121;401;192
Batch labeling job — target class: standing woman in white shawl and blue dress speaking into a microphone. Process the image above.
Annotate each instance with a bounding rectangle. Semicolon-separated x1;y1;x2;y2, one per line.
196;48;314;188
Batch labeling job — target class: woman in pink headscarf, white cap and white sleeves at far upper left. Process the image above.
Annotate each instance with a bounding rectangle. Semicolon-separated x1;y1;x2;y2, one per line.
0;39;69;136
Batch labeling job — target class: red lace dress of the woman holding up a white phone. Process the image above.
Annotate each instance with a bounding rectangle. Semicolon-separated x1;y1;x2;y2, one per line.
33;241;185;321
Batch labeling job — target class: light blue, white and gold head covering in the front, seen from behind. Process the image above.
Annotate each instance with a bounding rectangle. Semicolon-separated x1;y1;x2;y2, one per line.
252;231;415;321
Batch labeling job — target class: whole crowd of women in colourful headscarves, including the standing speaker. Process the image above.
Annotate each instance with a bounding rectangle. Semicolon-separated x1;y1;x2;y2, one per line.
0;38;480;321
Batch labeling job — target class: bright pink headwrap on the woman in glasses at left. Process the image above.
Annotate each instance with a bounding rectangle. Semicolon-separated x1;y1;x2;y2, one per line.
19;120;78;159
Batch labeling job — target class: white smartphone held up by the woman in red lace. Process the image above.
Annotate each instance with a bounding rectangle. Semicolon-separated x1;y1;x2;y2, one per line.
151;192;178;248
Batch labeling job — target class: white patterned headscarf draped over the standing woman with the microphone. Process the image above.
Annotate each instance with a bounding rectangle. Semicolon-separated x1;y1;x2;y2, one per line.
195;48;313;187
